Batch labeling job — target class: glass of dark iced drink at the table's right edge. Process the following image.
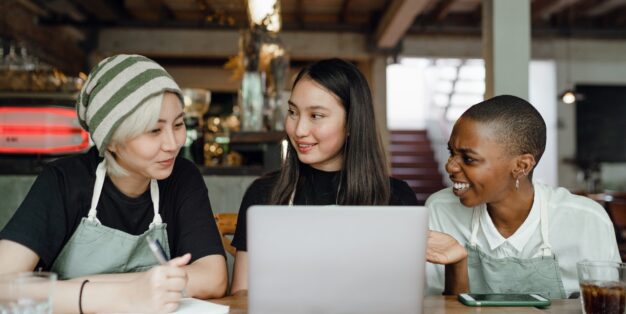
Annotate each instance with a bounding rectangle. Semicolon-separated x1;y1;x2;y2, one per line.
578;261;626;314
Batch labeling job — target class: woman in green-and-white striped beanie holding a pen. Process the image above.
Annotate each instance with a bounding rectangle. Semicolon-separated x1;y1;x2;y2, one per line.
0;55;227;313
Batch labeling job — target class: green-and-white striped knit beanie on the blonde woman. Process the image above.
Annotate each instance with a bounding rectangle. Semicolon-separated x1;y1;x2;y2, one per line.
76;55;183;156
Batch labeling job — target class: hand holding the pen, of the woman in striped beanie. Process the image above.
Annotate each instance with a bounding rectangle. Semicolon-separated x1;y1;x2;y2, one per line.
129;254;191;313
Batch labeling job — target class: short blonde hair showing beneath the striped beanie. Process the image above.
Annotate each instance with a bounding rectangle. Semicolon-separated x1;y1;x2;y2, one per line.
104;93;164;176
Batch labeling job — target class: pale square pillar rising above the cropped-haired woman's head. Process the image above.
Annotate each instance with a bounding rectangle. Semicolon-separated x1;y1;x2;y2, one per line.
482;0;531;99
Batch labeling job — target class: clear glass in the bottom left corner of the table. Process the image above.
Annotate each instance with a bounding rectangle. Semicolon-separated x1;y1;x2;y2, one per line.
0;272;57;314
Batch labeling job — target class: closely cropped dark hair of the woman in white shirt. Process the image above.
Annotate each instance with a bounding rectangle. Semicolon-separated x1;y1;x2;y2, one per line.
461;95;546;163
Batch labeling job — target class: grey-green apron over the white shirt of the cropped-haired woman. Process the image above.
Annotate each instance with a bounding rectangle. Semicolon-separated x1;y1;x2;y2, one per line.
466;189;566;299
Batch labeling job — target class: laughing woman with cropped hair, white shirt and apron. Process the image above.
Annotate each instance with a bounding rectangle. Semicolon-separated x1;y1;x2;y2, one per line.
426;95;620;299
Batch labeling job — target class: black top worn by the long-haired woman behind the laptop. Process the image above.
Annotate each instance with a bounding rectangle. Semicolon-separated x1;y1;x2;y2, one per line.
232;165;418;251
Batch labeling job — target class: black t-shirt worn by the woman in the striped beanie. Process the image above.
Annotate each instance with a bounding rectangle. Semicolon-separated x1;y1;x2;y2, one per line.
0;148;224;270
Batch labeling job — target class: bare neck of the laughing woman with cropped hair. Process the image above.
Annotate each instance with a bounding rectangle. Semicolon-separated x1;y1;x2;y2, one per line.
487;184;535;238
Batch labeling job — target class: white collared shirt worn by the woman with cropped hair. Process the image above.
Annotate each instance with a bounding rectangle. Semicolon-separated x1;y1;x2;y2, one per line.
426;183;621;295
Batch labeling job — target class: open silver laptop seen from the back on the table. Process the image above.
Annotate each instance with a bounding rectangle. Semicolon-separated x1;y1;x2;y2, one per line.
248;206;428;314
